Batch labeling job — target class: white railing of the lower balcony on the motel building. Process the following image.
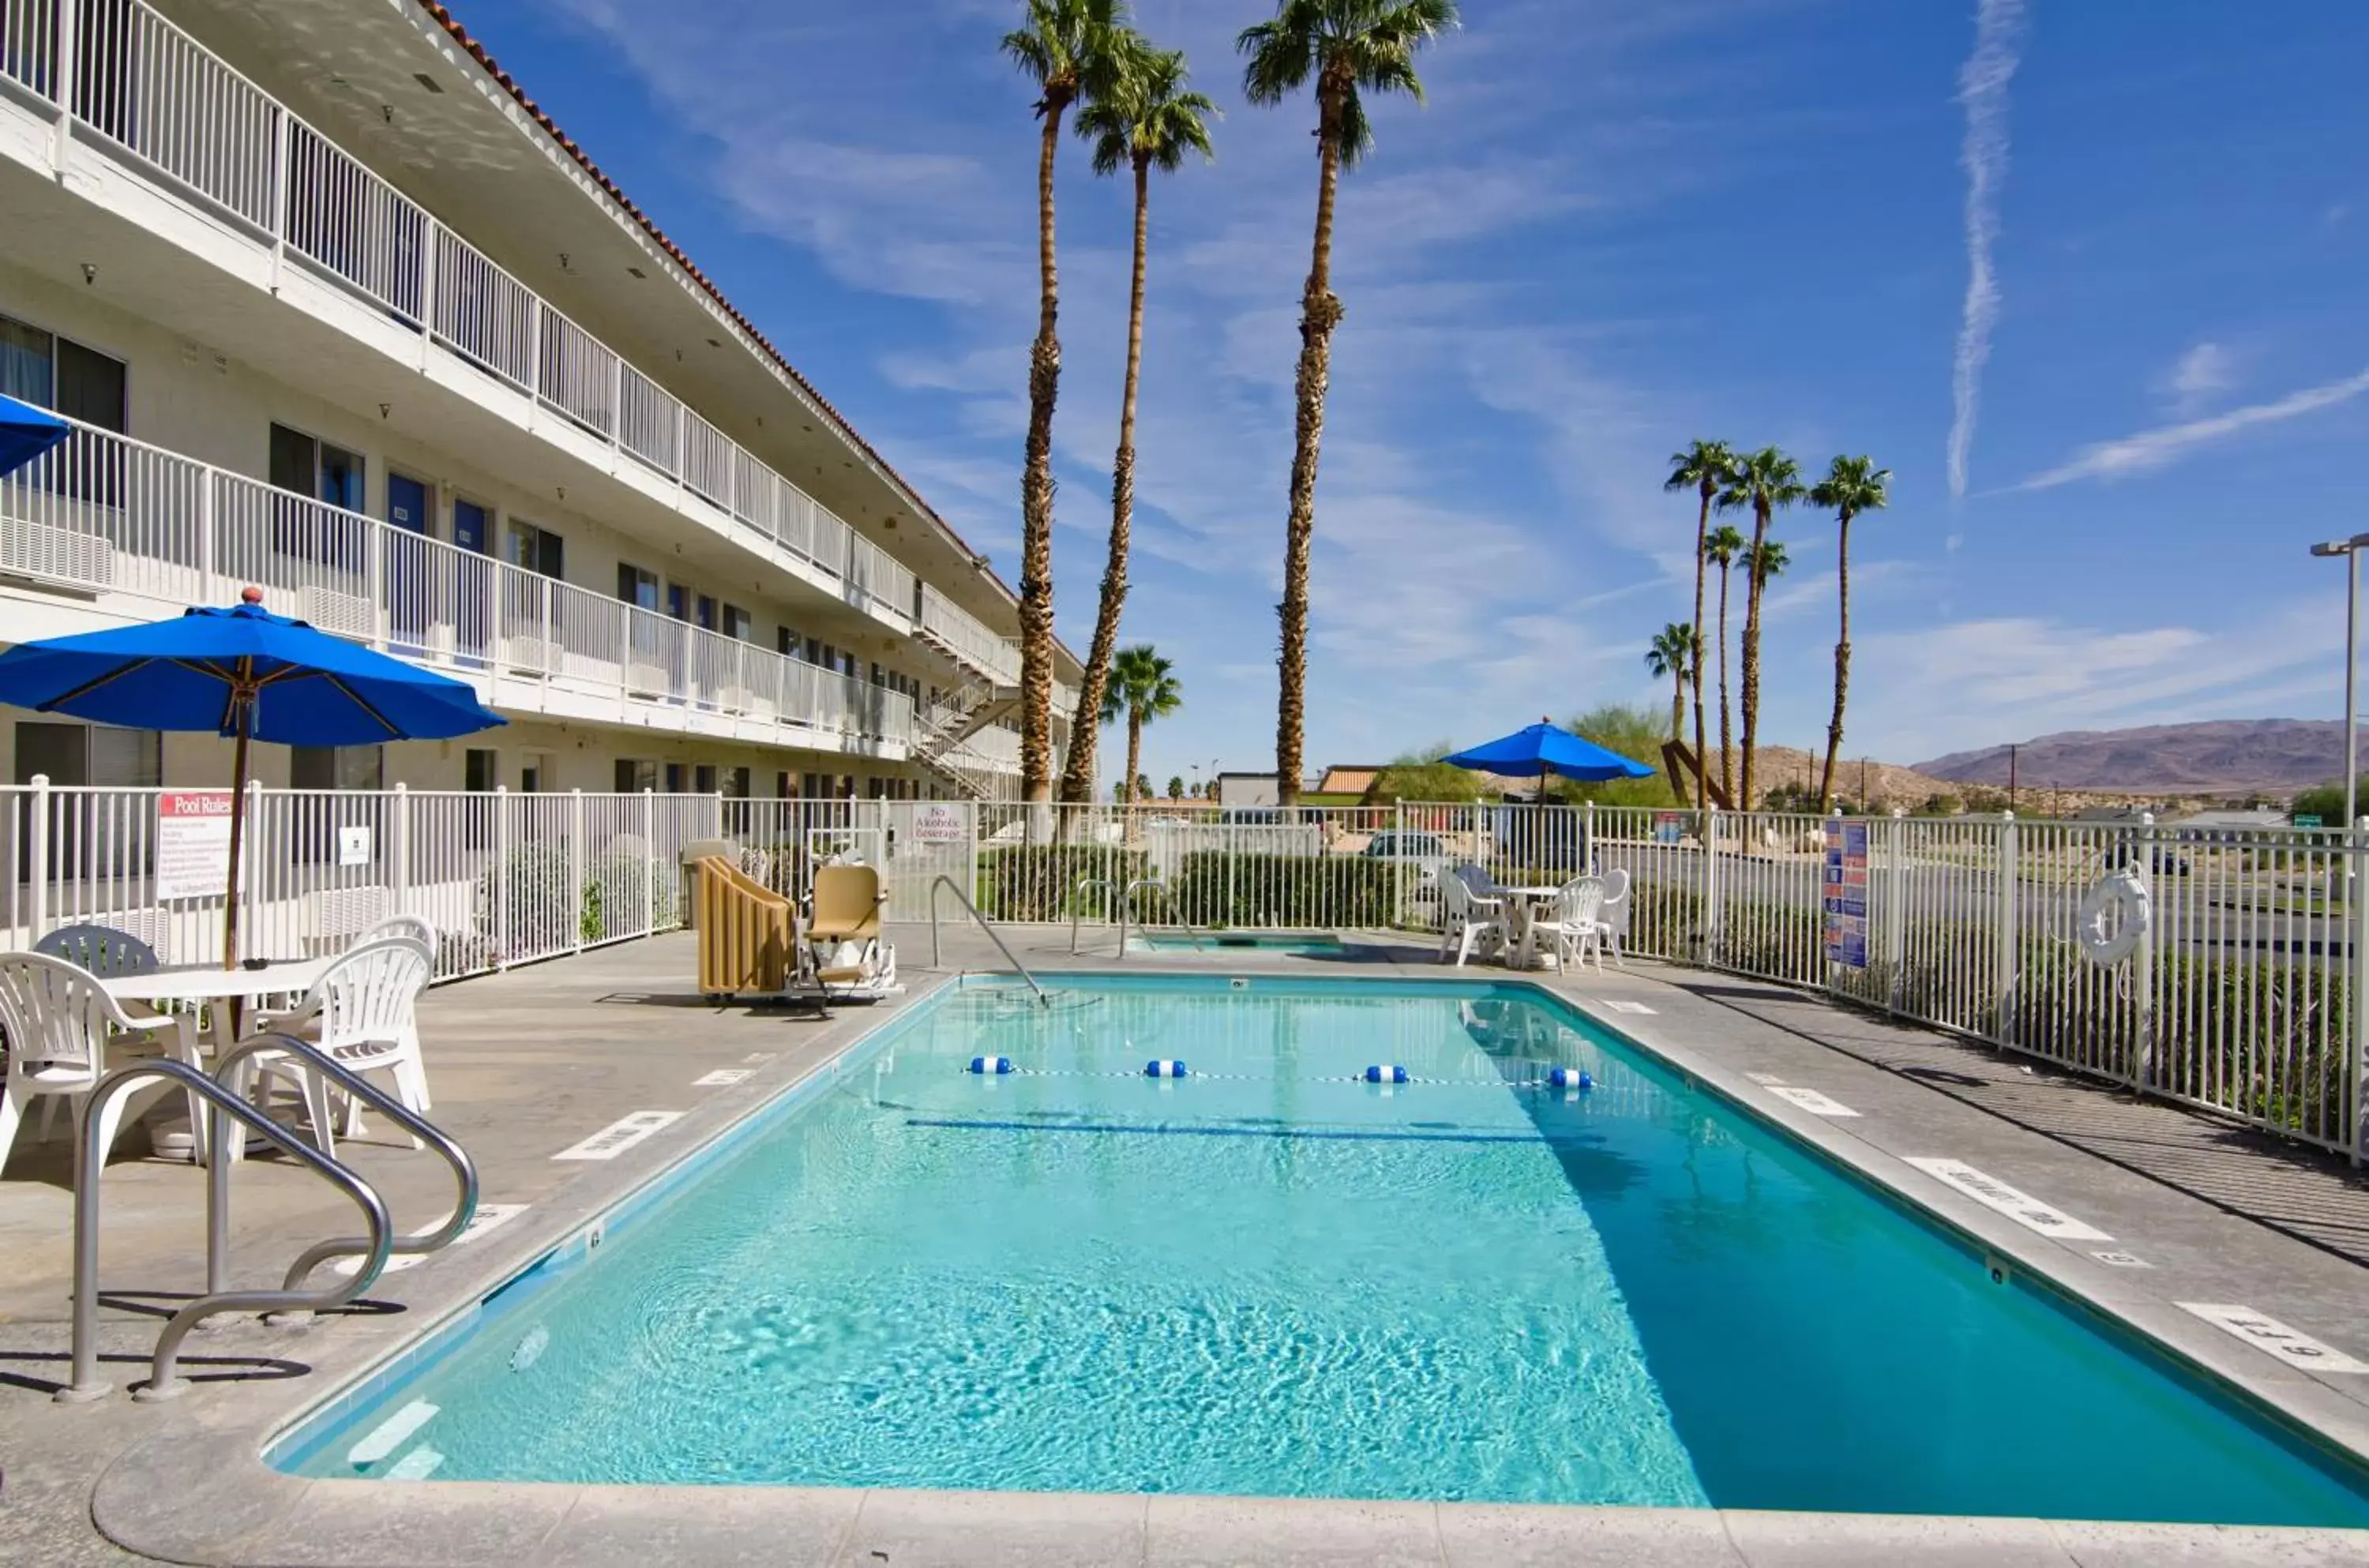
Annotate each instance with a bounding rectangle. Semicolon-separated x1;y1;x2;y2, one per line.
0;422;917;748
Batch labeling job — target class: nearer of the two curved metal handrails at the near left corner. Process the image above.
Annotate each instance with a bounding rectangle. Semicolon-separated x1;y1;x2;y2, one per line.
57;1061;393;1405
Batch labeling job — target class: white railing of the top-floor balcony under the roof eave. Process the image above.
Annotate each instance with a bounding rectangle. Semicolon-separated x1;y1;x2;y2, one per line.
0;0;938;630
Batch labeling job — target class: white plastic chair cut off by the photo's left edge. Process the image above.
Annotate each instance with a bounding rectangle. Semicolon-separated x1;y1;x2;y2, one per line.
0;952;199;1168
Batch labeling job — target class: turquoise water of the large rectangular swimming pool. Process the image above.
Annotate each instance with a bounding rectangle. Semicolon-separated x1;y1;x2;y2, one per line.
277;976;2369;1525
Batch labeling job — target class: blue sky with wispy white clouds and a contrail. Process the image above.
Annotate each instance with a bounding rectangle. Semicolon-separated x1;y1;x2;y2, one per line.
448;0;2369;779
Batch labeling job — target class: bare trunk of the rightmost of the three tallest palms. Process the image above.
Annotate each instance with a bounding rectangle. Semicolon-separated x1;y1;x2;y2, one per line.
1275;90;1341;805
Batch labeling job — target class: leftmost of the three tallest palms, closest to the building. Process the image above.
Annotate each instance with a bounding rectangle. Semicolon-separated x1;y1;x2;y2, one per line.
1002;0;1128;803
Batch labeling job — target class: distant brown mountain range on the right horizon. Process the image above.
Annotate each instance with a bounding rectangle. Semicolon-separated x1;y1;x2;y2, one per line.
1917;718;2345;796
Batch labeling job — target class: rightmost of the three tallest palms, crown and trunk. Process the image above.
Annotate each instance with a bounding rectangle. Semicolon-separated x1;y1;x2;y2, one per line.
1234;0;1457;805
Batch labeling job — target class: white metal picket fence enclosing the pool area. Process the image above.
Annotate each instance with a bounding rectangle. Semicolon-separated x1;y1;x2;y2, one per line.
0;784;2369;1161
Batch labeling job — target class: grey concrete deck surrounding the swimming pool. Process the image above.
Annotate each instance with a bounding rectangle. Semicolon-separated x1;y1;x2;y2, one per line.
0;928;2369;1568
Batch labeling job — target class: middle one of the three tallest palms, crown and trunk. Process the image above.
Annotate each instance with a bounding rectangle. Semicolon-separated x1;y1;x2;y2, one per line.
1061;40;1218;801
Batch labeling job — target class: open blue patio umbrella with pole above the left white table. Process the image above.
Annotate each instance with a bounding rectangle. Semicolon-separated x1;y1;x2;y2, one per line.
0;587;502;969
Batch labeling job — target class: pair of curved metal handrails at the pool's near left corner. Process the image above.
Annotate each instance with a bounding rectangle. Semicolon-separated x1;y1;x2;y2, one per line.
57;1033;479;1405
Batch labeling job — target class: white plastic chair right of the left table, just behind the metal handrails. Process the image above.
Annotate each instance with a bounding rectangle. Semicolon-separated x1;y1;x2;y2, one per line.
249;936;434;1156
